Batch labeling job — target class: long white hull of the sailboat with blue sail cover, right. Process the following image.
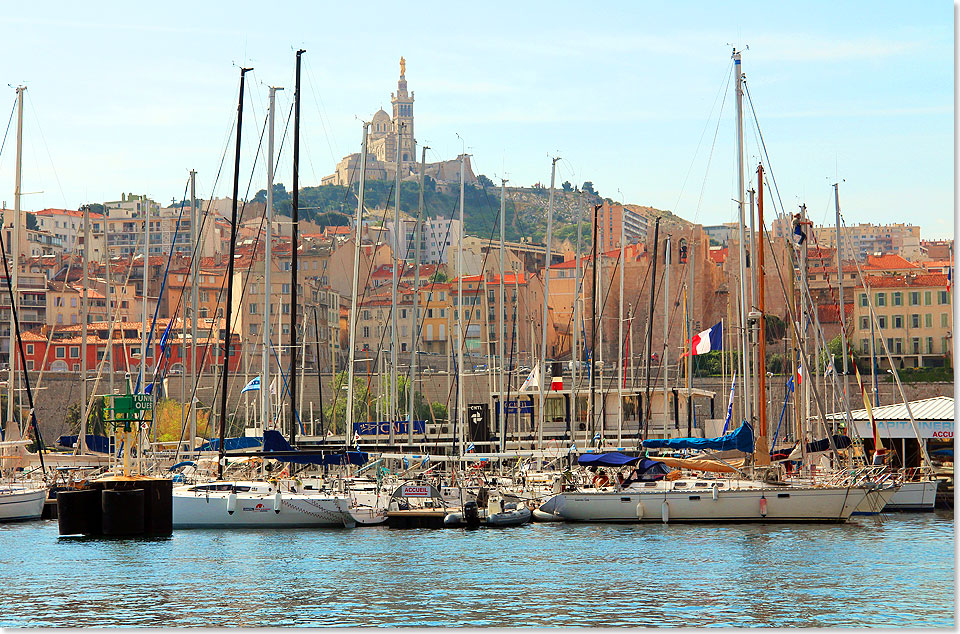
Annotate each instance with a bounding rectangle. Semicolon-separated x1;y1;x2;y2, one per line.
541;483;867;523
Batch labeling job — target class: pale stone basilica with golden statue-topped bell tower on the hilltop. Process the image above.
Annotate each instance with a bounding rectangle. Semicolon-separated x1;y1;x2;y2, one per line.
320;57;477;186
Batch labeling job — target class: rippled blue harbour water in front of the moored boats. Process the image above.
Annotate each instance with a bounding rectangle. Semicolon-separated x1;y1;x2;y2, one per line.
0;512;954;627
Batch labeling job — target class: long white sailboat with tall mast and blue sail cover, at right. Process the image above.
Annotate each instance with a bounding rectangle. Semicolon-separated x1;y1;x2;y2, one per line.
539;49;877;523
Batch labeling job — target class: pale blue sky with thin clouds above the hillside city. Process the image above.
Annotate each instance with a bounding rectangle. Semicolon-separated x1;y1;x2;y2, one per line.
0;0;954;238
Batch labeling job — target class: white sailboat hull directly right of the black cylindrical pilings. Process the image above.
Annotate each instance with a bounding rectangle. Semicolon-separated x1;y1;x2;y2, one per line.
173;486;356;528
